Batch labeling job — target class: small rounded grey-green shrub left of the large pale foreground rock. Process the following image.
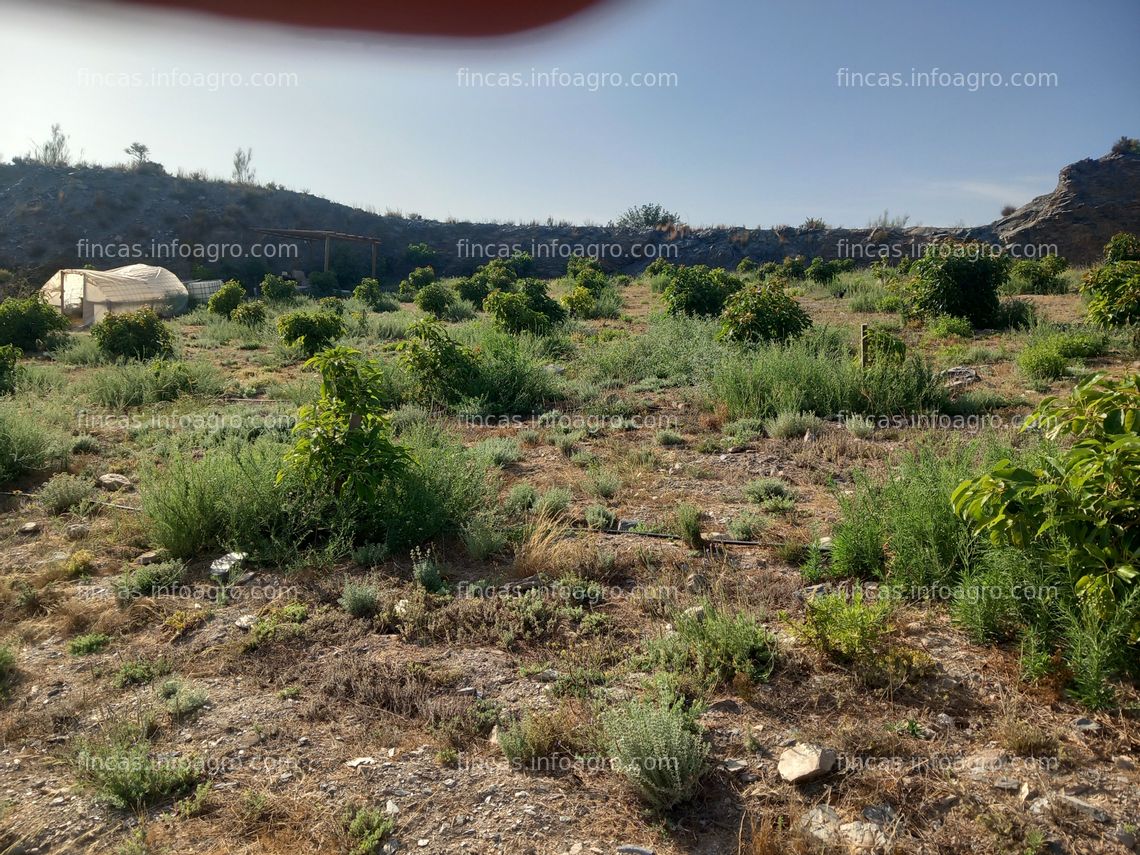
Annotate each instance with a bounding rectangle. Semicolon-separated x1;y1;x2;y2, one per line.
602;701;709;811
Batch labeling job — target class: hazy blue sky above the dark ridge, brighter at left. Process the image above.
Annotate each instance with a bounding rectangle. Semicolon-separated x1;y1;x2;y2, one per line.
0;0;1140;227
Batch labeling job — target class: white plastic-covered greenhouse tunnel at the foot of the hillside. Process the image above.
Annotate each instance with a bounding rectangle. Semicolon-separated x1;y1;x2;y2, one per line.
40;264;189;326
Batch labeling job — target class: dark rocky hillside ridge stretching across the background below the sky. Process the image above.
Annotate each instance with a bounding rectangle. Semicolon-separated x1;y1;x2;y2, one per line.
0;154;1140;288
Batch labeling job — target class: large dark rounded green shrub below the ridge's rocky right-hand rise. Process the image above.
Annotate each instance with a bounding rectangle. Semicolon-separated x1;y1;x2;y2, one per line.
904;242;1010;327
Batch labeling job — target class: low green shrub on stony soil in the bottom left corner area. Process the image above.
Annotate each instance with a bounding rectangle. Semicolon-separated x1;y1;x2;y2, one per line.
73;723;201;812
